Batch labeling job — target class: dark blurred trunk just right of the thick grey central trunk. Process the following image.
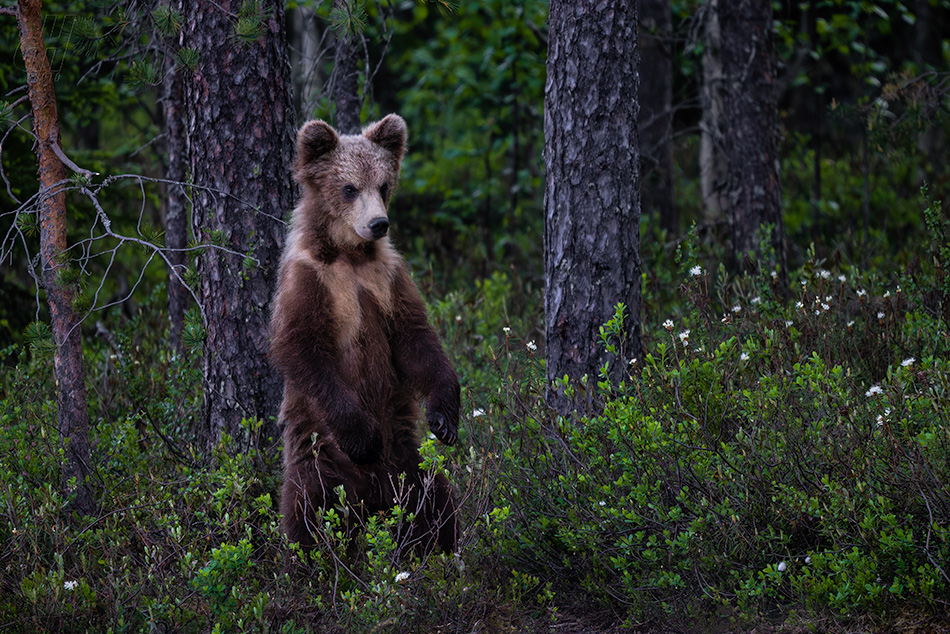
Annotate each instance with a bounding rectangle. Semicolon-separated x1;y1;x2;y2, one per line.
638;0;679;235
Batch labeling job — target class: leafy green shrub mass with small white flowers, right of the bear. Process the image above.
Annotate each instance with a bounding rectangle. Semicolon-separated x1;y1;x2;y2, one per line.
488;247;950;621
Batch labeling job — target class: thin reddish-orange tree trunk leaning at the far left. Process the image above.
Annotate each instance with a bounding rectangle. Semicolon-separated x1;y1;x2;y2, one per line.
17;0;92;512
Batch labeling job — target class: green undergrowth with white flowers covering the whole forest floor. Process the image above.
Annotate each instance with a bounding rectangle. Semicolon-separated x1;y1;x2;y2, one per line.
0;195;950;633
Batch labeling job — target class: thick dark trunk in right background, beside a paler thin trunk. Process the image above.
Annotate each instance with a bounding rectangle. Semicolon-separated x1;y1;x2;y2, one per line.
719;0;788;294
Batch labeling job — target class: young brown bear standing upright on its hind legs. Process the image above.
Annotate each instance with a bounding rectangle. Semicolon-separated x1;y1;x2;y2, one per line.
270;115;459;553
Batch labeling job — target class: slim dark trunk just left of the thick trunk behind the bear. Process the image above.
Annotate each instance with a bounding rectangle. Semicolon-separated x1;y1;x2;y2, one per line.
162;56;190;355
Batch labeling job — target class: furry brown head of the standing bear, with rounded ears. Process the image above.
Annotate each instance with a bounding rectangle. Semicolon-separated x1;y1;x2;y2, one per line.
294;114;407;250
